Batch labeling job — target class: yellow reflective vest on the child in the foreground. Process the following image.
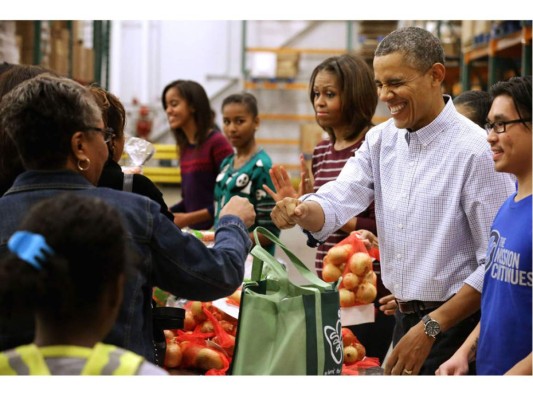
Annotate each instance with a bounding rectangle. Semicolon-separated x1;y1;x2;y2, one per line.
0;343;144;375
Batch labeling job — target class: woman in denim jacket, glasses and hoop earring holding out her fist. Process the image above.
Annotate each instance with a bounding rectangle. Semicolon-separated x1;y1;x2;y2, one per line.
0;74;255;361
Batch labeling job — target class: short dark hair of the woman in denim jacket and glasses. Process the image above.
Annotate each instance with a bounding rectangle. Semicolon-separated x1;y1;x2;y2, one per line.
0;74;102;169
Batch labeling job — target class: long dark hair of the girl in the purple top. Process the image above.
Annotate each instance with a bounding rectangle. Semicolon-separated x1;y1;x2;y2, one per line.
161;79;215;148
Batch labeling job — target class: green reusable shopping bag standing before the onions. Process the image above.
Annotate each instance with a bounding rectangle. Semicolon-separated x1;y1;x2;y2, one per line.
230;227;343;375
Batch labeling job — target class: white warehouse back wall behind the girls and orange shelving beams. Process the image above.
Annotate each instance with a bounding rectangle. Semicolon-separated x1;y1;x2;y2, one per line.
110;20;388;159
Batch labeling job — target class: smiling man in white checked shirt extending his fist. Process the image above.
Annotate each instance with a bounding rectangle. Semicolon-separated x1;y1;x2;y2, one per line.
272;27;514;375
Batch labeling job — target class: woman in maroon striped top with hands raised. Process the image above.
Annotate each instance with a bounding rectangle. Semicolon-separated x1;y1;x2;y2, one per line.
264;54;394;361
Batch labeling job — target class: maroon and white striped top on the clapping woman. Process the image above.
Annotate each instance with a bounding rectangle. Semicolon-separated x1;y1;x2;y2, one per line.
311;139;376;277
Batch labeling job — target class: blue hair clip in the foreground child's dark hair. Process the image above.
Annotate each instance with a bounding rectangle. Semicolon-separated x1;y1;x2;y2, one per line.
7;231;54;270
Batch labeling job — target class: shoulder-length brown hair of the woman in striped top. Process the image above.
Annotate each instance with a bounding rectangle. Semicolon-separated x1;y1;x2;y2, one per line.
309;54;378;142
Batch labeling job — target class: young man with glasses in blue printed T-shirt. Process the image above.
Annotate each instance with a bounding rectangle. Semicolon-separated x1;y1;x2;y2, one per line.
437;76;533;375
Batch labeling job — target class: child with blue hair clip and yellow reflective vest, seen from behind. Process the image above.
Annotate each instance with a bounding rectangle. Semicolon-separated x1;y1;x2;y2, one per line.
0;193;167;375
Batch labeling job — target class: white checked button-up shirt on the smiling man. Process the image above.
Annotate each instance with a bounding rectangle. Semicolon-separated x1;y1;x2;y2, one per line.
301;96;515;301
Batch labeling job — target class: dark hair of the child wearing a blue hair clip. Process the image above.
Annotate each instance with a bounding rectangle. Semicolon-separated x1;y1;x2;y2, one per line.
0;192;127;320
